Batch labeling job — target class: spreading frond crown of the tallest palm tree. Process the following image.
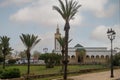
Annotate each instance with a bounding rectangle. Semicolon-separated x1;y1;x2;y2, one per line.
53;0;81;21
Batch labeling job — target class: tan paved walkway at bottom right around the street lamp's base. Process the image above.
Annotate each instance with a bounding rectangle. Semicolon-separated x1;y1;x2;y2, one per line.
70;69;120;80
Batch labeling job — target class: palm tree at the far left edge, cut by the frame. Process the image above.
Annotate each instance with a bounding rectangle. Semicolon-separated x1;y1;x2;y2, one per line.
0;36;13;69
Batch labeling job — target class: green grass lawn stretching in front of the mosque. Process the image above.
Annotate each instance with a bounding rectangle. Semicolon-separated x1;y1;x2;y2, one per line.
0;65;104;75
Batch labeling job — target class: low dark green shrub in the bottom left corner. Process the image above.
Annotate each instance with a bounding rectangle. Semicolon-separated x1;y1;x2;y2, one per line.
0;68;20;79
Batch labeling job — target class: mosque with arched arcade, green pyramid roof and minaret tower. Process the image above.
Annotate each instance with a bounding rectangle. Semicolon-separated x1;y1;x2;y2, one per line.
54;27;115;64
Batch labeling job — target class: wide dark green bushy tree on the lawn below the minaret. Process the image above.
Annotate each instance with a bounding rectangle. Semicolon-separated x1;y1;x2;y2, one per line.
39;53;61;68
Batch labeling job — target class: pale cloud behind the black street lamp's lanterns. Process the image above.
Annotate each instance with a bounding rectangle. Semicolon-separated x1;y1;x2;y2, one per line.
91;25;120;47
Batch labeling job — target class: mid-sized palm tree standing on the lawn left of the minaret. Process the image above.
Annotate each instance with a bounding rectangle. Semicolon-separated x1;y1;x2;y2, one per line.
20;34;40;75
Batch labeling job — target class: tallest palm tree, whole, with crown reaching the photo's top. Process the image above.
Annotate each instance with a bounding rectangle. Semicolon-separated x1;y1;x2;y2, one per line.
53;0;81;80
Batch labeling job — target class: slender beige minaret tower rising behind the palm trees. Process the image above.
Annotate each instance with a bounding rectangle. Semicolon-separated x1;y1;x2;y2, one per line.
55;24;61;51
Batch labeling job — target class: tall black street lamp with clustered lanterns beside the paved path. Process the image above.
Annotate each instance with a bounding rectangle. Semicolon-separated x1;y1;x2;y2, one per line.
107;28;116;78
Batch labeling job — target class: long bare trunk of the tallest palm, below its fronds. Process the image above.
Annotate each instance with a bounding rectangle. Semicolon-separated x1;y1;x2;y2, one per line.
64;21;70;80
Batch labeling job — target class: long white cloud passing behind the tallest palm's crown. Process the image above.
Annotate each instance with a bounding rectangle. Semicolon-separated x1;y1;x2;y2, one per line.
10;0;82;26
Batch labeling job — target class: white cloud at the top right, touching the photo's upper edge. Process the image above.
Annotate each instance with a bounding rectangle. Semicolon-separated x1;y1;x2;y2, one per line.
79;0;116;18
